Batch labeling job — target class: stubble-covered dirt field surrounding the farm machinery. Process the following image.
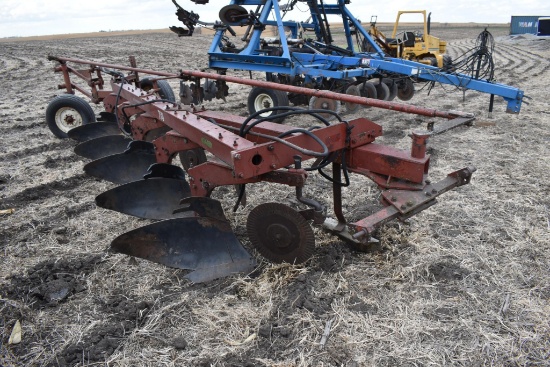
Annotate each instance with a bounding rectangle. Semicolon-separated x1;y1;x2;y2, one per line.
0;27;550;367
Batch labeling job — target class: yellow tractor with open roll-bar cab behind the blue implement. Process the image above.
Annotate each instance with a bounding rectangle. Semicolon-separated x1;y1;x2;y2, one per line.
364;10;452;69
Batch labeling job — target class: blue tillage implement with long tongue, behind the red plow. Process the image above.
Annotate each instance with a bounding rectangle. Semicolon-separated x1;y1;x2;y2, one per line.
171;0;524;113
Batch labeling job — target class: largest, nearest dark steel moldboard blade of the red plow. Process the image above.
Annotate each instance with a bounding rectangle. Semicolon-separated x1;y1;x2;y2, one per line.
111;217;256;283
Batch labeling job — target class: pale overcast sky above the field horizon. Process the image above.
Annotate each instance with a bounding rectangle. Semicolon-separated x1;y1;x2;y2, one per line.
0;0;550;37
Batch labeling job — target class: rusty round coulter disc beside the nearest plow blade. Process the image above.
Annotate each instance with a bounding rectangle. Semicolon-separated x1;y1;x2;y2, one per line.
246;203;315;264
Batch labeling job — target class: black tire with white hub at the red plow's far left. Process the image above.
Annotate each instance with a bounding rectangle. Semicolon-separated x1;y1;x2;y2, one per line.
46;94;95;139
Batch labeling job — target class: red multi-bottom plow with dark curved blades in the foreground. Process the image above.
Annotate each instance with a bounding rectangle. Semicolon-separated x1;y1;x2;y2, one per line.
47;56;475;282
